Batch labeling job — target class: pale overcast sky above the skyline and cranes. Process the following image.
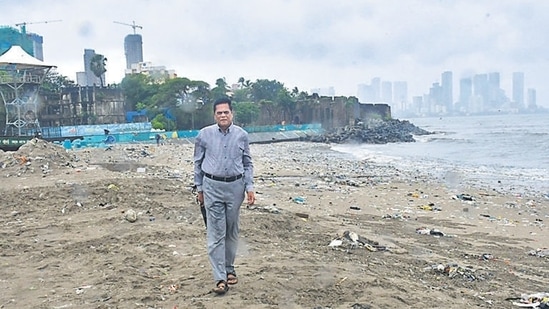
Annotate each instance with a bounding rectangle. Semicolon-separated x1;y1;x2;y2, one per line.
4;0;549;107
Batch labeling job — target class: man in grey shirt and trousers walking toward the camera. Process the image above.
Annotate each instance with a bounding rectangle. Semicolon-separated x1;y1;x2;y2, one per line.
194;98;255;294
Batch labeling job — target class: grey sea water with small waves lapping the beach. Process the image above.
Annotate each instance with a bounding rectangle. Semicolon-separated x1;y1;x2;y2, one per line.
333;114;549;198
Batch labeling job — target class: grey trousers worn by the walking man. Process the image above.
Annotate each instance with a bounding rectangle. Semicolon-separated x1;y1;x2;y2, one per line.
202;177;246;282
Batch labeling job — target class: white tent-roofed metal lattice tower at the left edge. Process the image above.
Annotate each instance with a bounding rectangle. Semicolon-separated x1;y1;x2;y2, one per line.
0;45;55;136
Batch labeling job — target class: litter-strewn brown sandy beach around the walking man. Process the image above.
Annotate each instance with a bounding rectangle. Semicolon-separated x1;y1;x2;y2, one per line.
0;140;549;309
